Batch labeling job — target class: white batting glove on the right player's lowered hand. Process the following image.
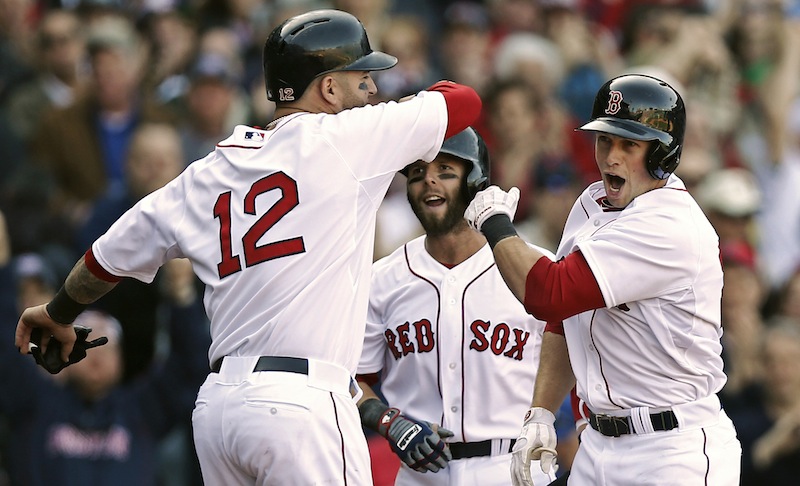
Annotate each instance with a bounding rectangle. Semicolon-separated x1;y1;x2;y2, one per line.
511;407;558;486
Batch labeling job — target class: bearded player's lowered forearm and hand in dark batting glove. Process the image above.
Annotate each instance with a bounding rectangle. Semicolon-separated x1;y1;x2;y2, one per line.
358;382;453;473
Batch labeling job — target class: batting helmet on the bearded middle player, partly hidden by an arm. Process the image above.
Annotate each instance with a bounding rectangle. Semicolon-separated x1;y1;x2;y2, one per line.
400;127;490;201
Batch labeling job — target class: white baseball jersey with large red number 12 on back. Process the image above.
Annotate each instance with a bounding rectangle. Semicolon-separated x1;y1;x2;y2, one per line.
92;92;447;373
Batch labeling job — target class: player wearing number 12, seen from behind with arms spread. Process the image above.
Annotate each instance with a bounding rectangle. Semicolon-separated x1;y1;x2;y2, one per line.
16;10;481;485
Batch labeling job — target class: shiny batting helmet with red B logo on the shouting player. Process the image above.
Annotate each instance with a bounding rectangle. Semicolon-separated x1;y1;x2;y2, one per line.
578;74;686;179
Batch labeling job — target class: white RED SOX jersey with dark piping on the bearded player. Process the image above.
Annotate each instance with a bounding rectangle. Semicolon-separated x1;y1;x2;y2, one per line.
358;236;549;484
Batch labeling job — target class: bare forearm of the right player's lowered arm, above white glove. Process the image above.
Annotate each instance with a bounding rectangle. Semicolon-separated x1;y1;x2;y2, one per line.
531;332;575;413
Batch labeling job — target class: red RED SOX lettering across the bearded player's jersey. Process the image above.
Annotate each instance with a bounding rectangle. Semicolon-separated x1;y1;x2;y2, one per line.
384;319;531;361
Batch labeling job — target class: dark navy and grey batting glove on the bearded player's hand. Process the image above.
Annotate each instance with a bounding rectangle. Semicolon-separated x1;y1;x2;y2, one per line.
378;408;453;473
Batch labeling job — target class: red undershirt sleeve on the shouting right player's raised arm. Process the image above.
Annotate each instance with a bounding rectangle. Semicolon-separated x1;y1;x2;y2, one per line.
525;251;605;322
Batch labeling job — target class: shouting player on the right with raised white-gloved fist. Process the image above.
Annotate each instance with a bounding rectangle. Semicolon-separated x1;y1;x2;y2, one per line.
465;74;741;486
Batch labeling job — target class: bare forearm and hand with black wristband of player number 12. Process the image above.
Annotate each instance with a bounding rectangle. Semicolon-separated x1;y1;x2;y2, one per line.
14;256;116;362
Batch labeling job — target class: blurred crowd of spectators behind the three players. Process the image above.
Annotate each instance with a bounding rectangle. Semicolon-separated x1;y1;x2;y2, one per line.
0;0;800;486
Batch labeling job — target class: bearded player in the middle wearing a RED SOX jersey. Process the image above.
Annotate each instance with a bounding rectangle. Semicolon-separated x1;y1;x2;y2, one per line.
357;128;554;486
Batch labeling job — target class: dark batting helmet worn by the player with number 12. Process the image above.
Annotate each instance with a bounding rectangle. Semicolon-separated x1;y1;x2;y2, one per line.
264;10;397;101
